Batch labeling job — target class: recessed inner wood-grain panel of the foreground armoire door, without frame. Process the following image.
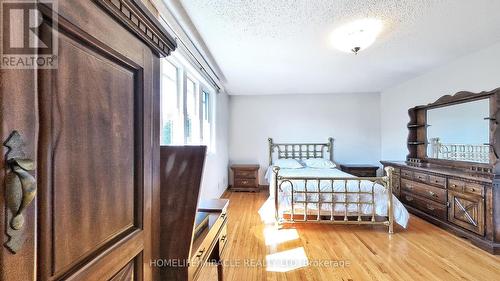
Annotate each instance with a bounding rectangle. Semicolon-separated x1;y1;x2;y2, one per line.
52;30;140;272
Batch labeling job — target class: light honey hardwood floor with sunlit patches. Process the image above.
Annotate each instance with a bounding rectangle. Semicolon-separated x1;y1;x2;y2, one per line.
204;189;500;281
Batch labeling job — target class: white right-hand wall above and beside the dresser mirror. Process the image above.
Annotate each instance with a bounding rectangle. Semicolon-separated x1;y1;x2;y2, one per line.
381;40;500;160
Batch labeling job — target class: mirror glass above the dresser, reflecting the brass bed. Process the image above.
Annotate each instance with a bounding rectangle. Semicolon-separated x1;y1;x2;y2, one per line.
427;99;490;163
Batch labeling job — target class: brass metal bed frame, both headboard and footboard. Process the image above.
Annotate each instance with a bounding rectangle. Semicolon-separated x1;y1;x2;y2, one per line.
268;137;394;233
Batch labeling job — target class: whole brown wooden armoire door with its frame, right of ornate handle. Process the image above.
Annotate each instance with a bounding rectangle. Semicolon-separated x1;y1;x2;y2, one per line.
37;4;153;280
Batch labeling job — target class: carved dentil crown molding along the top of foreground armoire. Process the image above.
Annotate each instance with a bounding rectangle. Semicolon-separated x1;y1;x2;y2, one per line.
93;0;177;57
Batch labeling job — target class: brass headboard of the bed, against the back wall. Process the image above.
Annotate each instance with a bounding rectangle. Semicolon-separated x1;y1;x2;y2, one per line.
267;137;335;166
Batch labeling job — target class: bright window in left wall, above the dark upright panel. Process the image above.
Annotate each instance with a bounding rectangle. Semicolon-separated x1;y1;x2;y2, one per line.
160;57;214;152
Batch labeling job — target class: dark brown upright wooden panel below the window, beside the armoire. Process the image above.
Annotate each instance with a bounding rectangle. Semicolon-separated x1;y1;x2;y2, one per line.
158;146;207;280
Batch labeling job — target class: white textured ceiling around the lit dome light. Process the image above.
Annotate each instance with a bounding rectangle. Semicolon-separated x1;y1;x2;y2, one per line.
180;0;500;94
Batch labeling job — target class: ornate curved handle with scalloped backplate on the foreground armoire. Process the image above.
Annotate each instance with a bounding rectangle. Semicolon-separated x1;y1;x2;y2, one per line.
4;131;37;254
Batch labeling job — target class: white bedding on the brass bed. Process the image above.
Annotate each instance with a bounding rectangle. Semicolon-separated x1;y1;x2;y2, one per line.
266;167;409;228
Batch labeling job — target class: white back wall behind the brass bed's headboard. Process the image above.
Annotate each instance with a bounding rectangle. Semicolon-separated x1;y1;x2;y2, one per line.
229;93;380;184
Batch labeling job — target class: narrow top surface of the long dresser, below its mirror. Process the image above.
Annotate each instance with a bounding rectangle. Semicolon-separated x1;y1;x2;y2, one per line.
380;161;492;183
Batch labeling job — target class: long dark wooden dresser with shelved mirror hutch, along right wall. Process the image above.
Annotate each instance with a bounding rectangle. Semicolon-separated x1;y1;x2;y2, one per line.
381;89;500;254
